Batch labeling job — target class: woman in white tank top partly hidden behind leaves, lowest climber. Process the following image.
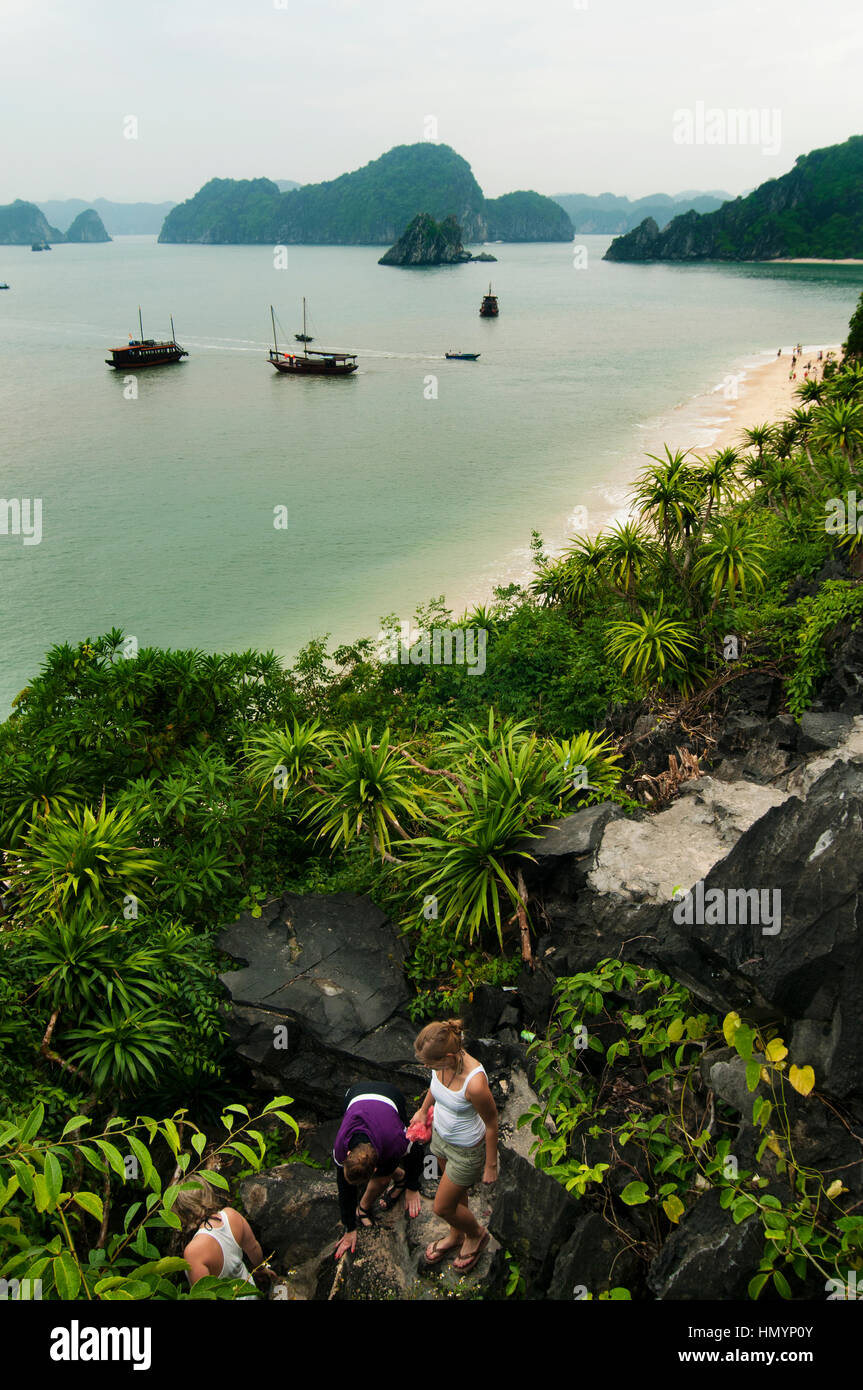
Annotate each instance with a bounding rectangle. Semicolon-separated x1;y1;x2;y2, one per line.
174;1177;277;1298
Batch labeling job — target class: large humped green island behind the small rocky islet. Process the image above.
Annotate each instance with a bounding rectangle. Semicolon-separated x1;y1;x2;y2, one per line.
158;142;573;246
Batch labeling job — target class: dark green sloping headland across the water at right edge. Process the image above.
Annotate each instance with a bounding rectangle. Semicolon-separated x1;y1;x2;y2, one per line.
605;135;863;261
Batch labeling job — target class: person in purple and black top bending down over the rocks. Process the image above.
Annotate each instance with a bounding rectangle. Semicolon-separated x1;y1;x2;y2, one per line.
332;1081;425;1259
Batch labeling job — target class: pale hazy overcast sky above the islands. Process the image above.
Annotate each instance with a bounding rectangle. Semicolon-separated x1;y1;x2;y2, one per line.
0;0;863;202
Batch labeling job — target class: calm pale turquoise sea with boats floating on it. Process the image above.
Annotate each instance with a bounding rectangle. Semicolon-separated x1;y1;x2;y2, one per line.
0;236;862;716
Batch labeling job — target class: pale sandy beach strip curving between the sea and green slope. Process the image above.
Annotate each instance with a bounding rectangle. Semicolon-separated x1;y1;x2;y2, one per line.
446;343;842;616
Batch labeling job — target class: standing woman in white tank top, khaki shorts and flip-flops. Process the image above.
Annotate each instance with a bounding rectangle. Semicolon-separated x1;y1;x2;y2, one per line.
411;1019;498;1273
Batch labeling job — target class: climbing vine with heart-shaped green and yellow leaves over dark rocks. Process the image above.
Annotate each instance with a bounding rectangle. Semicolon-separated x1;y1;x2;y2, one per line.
521;960;863;1298
